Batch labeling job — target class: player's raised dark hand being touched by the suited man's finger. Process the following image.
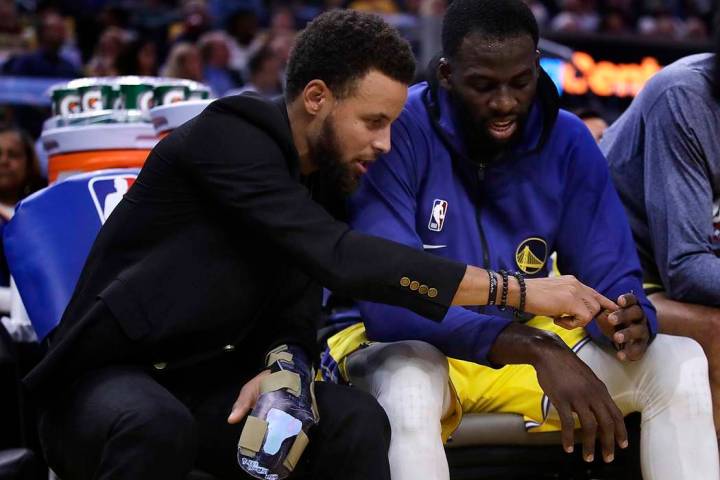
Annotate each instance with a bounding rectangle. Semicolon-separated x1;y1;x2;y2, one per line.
598;293;650;361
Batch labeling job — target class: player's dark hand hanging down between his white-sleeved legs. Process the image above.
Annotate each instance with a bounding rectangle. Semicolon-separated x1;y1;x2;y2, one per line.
535;340;628;462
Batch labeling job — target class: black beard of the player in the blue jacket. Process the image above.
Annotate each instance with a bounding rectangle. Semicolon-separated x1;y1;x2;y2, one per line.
449;90;528;163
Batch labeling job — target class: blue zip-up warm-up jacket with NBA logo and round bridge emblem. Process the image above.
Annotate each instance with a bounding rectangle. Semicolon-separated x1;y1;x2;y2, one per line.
349;74;657;364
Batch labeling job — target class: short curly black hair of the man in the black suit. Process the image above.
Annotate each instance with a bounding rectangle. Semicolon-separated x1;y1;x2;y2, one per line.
285;10;415;101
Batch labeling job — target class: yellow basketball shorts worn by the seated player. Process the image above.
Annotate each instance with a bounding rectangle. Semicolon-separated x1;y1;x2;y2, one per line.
324;317;590;441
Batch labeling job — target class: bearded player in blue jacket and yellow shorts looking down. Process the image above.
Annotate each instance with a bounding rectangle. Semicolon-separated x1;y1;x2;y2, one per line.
325;0;720;480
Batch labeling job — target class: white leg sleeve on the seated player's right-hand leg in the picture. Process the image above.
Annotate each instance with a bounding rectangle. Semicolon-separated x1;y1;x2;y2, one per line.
578;335;720;480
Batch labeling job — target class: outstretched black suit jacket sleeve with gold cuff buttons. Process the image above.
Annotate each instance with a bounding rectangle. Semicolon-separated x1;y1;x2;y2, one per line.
171;102;466;320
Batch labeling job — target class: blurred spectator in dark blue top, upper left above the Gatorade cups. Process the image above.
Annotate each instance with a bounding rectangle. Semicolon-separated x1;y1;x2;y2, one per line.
5;11;81;78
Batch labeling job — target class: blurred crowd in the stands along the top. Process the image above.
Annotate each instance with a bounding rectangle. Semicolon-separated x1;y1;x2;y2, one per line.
0;0;713;100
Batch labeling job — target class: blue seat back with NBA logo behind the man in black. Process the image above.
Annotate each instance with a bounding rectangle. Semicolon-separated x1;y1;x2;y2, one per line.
0;172;219;480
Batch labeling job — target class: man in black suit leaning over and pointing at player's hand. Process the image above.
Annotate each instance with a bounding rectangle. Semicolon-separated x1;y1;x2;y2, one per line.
26;7;613;480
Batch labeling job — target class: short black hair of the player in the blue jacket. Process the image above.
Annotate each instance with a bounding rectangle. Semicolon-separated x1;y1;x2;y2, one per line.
442;0;540;58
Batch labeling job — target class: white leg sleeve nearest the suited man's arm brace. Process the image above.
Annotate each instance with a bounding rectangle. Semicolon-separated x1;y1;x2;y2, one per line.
347;340;450;480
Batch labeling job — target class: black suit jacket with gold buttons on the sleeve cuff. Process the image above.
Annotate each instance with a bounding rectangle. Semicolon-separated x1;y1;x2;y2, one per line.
26;95;465;389
